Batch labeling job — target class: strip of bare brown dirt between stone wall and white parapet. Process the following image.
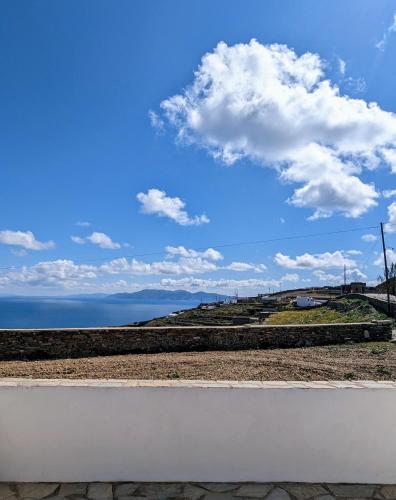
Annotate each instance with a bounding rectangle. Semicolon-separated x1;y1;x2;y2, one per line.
0;342;396;381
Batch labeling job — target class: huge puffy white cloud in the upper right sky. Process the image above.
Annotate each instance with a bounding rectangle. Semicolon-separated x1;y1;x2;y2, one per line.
161;40;396;218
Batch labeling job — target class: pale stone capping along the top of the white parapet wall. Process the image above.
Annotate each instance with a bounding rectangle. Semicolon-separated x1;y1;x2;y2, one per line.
0;378;396;390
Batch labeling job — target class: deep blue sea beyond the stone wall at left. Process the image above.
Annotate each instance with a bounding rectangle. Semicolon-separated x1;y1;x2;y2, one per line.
0;297;198;328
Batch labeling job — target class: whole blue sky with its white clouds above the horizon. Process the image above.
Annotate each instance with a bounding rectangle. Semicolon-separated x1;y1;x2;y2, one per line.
0;0;396;295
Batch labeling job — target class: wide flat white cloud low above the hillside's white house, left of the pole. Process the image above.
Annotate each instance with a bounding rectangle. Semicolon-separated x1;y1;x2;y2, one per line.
274;250;356;269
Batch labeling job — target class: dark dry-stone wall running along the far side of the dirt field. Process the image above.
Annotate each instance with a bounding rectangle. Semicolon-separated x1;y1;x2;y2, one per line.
0;321;392;360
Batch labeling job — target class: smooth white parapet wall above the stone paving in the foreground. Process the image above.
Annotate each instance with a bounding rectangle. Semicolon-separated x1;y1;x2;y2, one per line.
0;379;396;483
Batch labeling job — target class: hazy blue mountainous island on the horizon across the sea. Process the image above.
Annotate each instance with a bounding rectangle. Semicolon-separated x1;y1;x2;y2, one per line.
108;289;229;302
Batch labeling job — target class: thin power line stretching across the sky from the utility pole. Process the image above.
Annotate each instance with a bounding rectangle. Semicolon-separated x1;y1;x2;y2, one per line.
0;225;379;271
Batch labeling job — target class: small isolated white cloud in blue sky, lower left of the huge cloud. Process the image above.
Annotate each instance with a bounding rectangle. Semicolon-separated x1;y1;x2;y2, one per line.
137;189;209;226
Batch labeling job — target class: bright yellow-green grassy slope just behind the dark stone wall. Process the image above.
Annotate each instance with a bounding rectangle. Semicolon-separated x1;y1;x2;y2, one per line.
266;299;387;325
